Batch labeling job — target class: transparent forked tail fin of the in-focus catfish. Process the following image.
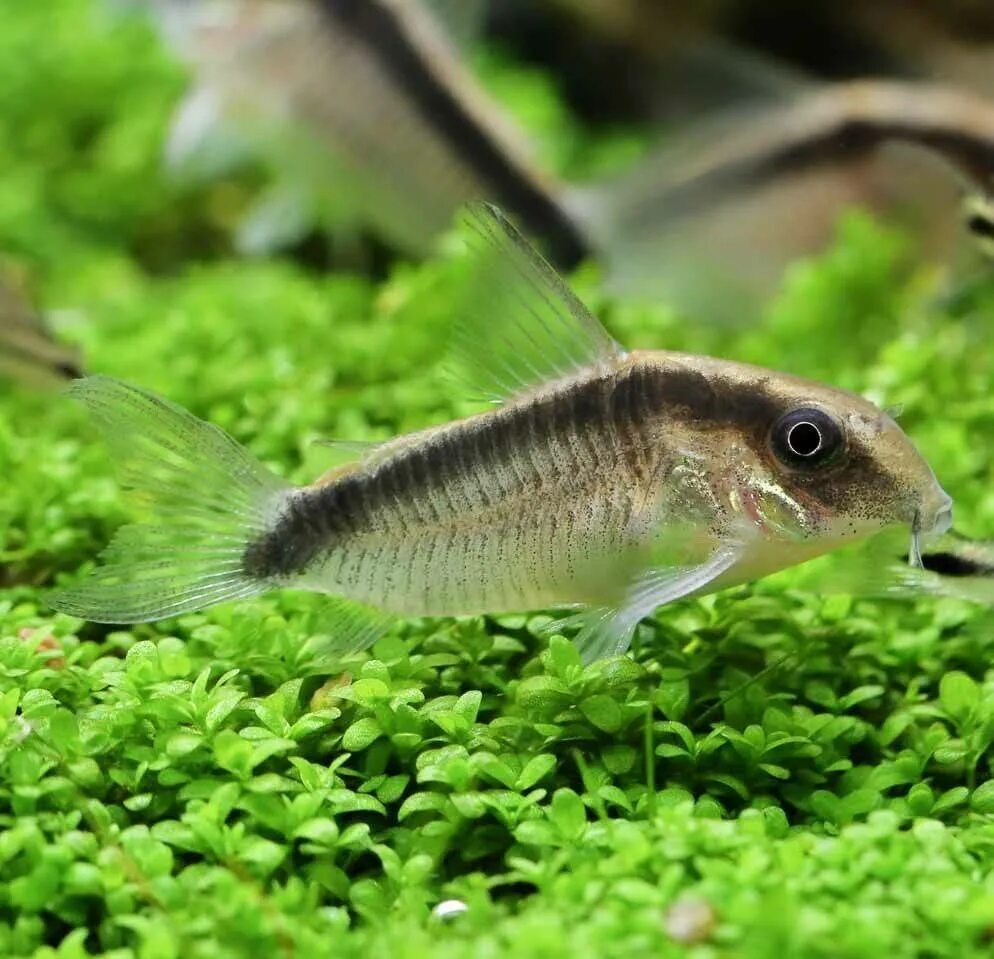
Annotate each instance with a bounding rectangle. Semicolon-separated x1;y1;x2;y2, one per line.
50;376;291;623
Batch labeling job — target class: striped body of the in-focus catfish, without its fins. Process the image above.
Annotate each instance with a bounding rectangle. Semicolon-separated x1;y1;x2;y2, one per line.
253;352;947;615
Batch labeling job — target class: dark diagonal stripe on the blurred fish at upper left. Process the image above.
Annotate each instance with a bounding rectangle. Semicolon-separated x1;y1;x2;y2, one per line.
317;0;589;270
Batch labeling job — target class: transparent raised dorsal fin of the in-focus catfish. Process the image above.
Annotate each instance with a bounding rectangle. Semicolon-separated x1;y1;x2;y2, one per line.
452;202;624;402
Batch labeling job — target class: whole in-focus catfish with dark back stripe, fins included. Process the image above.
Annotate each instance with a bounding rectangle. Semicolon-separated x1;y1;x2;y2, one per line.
54;204;951;660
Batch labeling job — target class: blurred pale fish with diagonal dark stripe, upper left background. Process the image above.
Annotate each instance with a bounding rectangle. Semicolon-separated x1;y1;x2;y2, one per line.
139;0;576;265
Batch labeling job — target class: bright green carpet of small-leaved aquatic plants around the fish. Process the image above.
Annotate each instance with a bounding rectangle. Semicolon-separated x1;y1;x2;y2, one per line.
0;0;994;959
